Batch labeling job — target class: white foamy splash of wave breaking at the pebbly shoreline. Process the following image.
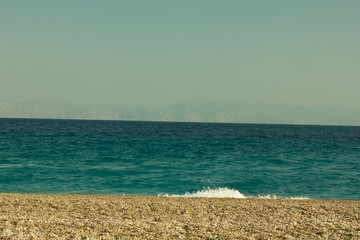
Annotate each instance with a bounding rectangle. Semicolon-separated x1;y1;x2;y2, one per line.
159;187;310;200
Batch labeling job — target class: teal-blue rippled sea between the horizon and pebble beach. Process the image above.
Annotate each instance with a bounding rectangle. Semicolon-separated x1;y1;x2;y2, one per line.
0;118;360;201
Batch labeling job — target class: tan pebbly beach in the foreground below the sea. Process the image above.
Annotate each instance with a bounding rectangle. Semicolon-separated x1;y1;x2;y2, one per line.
0;194;360;239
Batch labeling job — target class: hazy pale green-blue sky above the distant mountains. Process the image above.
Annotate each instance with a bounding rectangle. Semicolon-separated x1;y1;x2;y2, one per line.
0;0;360;110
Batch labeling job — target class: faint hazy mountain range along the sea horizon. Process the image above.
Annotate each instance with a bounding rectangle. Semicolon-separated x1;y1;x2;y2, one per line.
0;100;360;125
